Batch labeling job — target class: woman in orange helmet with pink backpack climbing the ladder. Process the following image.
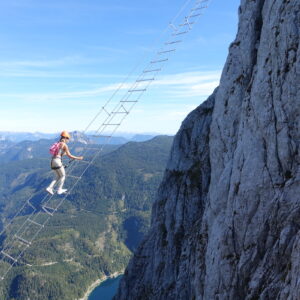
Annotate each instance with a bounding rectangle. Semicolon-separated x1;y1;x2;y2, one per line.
46;131;83;195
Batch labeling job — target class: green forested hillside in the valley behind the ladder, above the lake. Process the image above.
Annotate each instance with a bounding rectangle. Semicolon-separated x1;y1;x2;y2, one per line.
0;136;173;300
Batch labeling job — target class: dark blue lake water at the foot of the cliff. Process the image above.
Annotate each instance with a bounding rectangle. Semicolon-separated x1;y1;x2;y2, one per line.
88;275;122;300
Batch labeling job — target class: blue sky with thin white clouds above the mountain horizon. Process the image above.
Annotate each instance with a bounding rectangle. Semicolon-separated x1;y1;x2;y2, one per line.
0;0;239;134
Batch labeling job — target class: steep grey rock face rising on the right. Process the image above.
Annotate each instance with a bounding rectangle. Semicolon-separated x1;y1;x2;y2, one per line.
115;0;300;300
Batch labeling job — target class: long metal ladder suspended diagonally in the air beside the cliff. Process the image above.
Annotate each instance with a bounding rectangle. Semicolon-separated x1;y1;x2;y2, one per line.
0;0;210;280
